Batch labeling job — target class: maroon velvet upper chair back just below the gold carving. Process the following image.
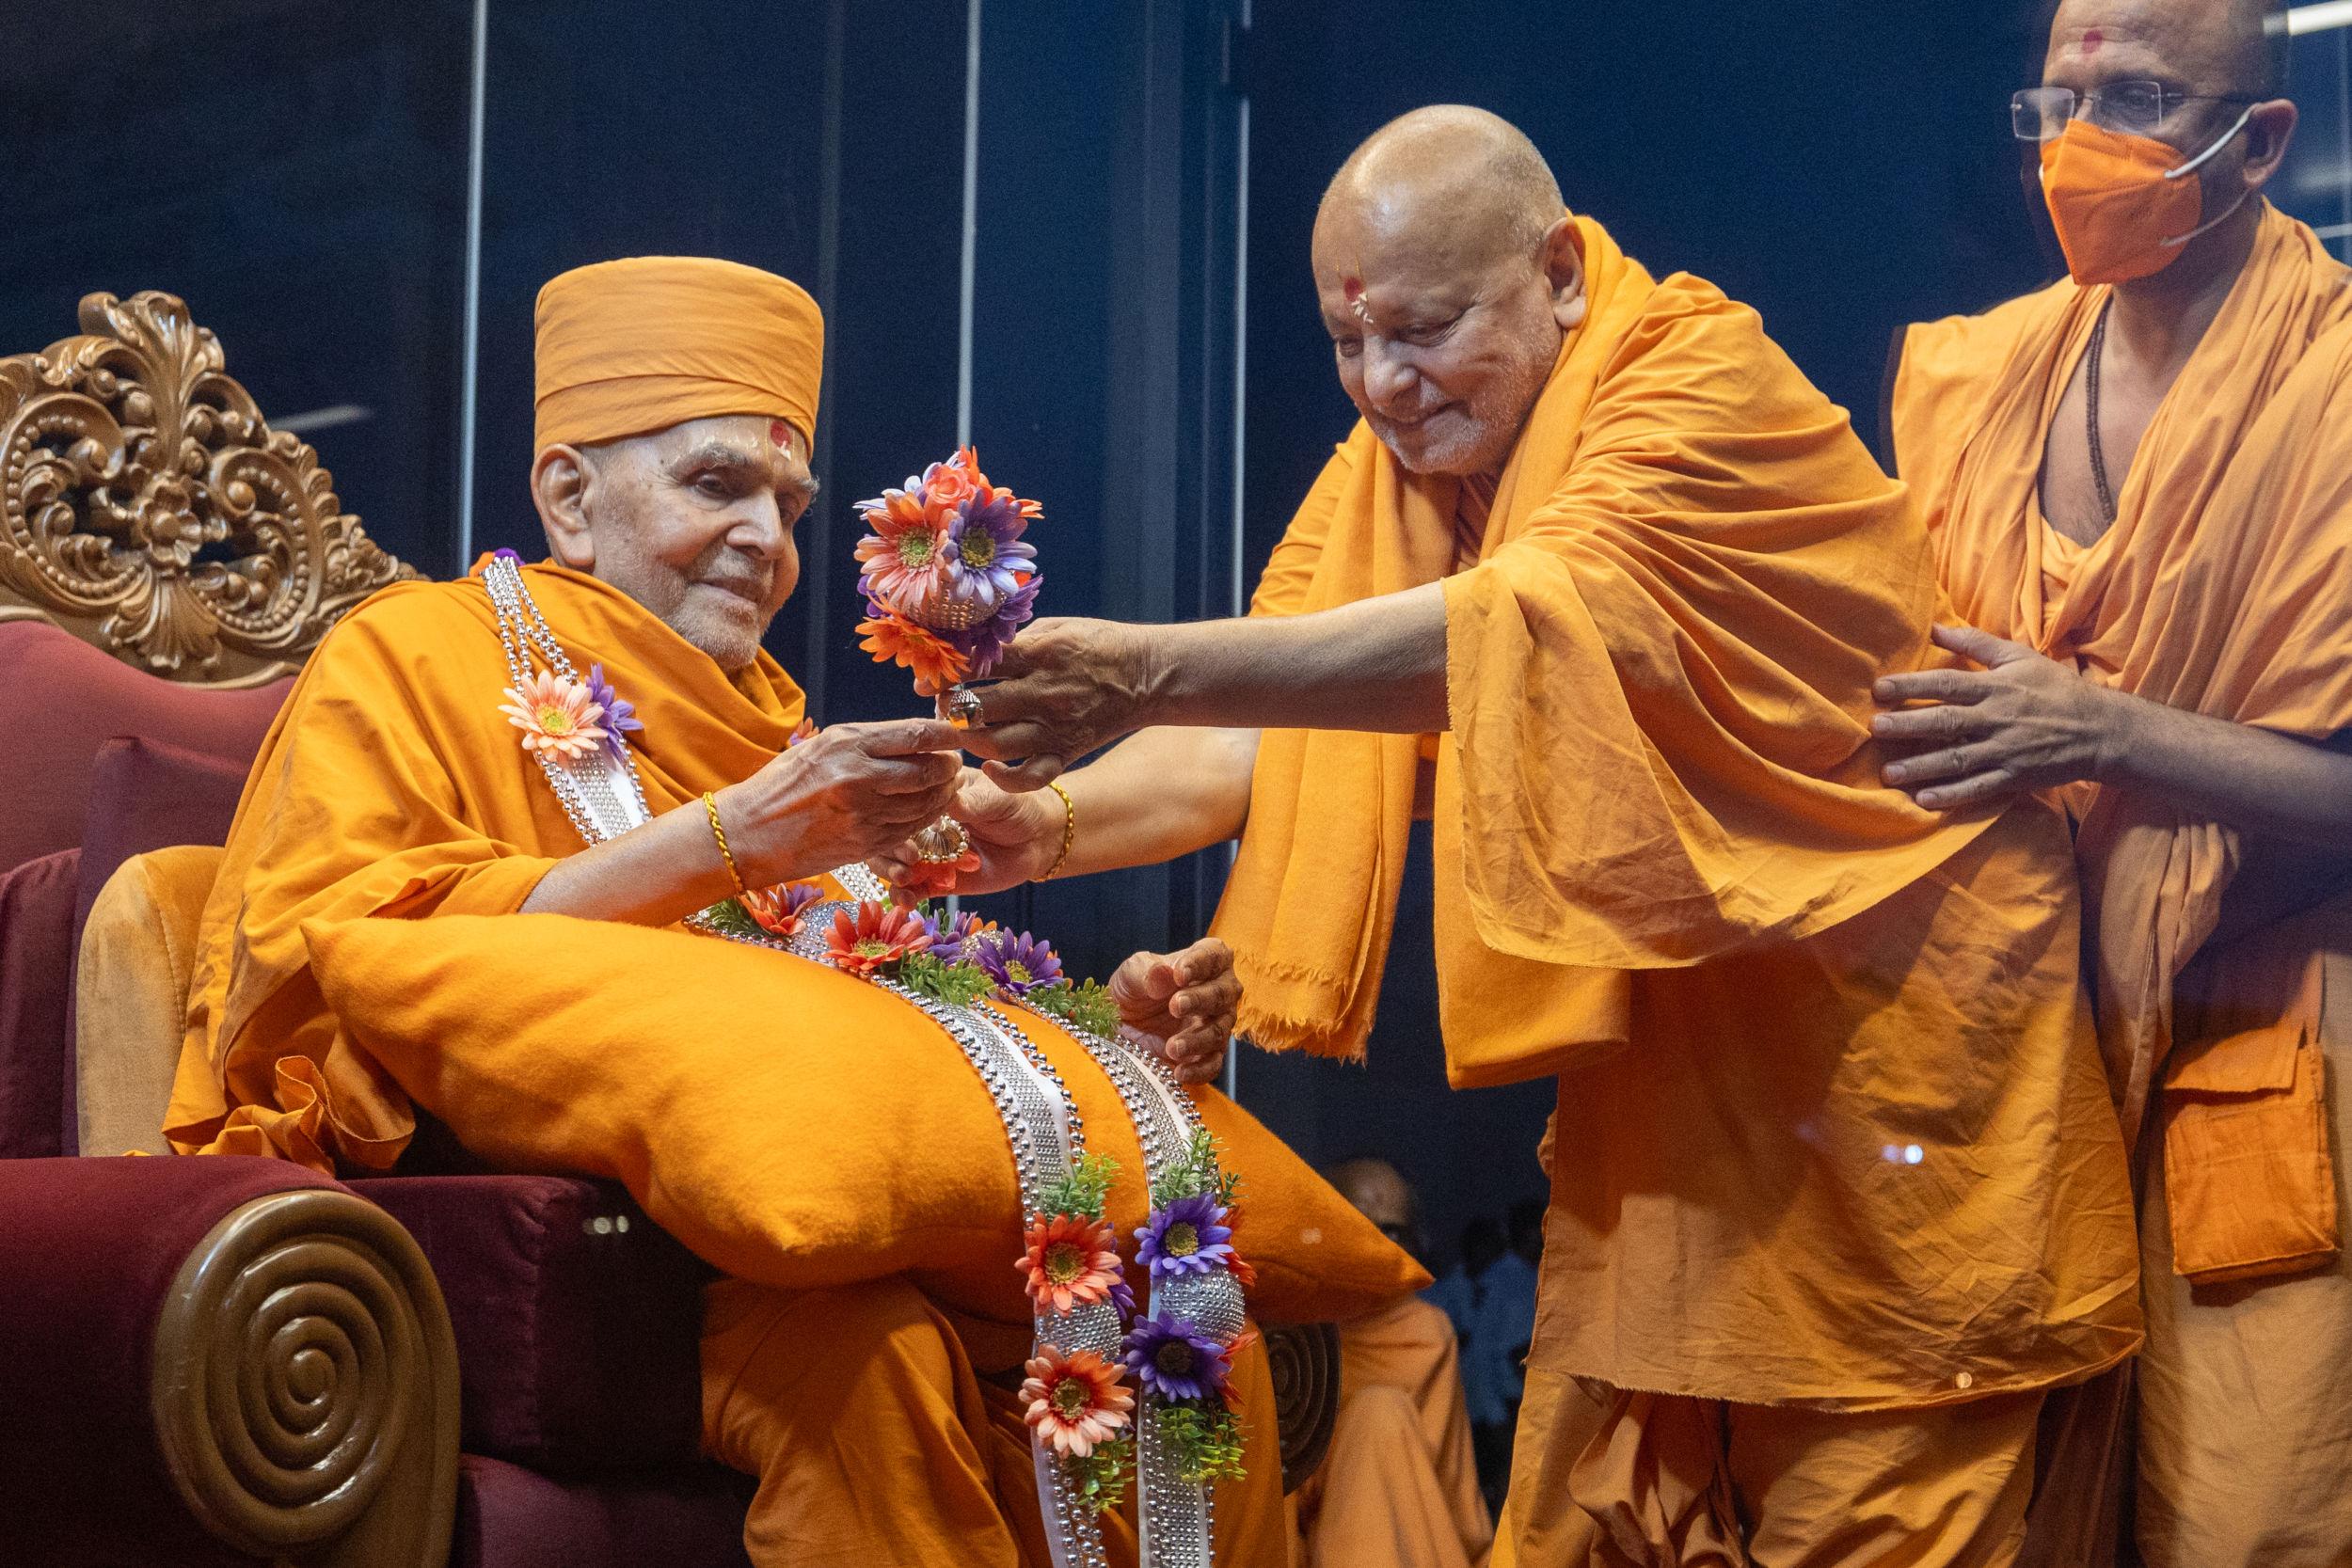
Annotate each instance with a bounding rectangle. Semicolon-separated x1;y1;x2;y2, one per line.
0;621;294;870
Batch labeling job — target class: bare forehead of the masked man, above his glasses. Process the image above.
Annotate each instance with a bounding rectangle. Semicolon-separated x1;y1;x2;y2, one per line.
2044;0;2289;99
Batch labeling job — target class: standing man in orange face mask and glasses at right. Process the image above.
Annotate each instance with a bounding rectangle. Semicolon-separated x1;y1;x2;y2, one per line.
1877;0;2352;1568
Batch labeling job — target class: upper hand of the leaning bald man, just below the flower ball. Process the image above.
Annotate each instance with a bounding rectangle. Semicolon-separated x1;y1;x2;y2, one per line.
941;618;1151;792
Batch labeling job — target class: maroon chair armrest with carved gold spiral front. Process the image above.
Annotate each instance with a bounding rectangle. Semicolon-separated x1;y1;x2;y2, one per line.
0;1157;459;1568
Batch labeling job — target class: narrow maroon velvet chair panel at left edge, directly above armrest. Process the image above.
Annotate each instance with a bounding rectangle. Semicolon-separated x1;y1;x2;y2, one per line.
0;848;83;1161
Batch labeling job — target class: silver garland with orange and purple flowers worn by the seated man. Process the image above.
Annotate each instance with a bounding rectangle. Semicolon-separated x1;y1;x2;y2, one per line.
468;552;1245;1568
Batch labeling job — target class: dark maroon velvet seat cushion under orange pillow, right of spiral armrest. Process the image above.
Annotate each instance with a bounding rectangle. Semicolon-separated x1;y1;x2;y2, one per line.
351;1176;701;1476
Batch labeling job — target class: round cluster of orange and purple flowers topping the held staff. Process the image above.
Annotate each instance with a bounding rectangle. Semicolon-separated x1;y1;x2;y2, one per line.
859;447;1042;712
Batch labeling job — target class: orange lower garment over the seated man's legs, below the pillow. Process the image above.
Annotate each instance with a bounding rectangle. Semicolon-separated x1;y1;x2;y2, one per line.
704;1279;1292;1568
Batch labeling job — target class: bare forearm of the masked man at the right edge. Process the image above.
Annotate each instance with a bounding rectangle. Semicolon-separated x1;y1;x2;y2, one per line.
2101;691;2352;847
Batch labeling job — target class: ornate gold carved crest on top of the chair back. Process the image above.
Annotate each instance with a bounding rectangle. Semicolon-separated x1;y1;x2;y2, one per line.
0;289;417;687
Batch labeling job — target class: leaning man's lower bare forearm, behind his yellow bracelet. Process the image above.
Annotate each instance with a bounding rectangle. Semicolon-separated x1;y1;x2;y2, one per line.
1061;729;1259;877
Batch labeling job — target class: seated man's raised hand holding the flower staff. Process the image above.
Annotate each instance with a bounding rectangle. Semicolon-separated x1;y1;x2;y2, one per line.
715;720;969;886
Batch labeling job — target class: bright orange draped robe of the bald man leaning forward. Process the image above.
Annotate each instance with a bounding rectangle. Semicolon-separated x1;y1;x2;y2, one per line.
1216;218;2140;1410
